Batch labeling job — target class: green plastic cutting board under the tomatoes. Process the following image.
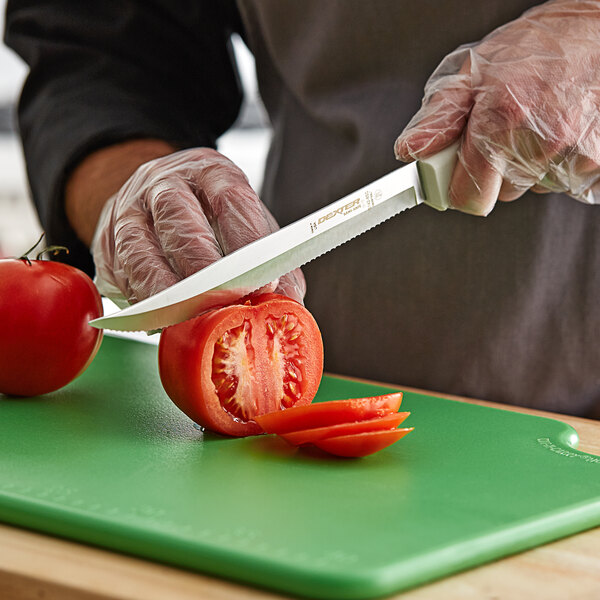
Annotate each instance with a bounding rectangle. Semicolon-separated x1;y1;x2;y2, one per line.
0;337;600;598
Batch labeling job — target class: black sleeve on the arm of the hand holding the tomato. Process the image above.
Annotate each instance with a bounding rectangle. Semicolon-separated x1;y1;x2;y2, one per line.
5;0;242;274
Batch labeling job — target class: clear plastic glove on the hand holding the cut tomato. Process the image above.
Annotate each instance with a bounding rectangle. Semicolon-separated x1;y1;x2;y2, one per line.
92;148;306;307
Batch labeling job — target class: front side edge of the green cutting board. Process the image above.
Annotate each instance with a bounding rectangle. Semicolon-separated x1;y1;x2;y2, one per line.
0;488;600;600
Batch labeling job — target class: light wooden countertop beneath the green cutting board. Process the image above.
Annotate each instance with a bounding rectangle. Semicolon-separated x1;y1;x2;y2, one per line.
0;388;600;600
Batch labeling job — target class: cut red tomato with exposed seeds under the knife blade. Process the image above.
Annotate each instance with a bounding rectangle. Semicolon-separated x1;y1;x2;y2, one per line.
158;294;323;436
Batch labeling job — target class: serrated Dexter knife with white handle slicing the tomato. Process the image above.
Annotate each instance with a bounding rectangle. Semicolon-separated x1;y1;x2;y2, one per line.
90;142;458;331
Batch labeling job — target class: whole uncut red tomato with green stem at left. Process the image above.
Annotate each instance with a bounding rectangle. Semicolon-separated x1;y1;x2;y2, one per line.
0;259;102;396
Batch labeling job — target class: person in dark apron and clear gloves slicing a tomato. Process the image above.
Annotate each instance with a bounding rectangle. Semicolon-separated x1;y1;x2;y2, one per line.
5;0;600;417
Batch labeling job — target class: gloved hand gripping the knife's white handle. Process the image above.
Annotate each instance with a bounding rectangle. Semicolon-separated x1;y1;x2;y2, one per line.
395;0;600;215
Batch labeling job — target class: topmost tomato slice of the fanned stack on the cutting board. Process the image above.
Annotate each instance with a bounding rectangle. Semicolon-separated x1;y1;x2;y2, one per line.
254;392;402;434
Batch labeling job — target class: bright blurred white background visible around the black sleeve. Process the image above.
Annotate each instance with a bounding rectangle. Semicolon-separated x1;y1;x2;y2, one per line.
0;0;270;257
